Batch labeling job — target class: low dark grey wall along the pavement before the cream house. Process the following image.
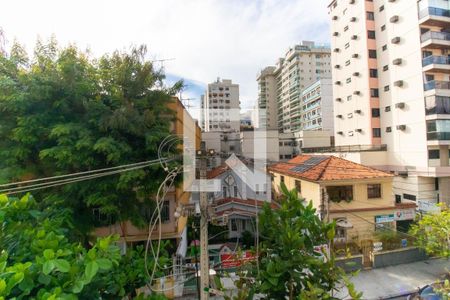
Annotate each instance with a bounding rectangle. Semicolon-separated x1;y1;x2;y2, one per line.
373;248;428;268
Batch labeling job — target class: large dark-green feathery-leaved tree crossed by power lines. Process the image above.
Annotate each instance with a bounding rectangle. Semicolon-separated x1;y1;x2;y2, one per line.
0;38;181;233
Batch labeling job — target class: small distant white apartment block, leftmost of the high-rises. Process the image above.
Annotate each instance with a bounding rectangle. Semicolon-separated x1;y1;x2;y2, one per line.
201;78;240;132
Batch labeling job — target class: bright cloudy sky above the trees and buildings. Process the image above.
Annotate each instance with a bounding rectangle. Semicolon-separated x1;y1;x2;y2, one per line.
0;0;330;115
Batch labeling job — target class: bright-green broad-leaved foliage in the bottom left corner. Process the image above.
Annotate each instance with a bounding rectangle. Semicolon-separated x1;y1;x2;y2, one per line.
0;195;166;299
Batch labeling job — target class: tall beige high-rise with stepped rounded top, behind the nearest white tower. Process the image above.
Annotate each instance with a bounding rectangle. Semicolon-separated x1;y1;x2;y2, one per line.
257;41;331;133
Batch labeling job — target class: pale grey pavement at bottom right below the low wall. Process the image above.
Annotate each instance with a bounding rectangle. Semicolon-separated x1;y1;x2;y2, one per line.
336;259;450;300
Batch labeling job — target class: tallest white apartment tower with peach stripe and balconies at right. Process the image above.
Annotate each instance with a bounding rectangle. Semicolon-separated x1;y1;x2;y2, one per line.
329;0;450;207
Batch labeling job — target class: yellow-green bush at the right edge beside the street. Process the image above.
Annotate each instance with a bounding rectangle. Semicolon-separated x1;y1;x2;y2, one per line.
410;205;450;259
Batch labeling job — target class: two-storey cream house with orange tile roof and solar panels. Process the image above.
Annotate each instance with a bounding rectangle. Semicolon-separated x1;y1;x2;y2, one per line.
269;155;416;243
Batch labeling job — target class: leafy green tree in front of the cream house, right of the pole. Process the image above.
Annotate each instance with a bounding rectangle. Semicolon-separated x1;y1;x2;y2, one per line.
256;184;361;299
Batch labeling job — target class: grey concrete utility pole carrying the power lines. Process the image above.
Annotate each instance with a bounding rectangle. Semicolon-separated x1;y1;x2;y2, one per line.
200;150;209;300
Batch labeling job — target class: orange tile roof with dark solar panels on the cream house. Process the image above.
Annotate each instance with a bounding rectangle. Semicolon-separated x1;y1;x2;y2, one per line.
268;155;393;181
